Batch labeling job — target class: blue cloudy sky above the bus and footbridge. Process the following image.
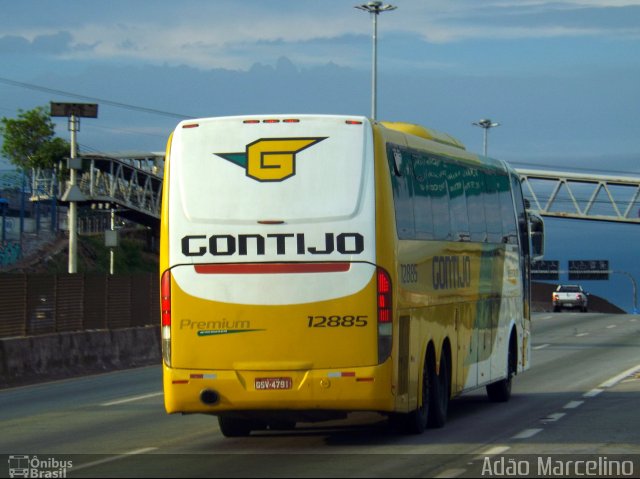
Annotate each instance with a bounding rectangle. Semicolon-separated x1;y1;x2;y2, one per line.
0;0;640;312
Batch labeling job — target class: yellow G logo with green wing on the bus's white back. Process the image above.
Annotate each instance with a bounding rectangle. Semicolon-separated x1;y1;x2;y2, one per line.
214;137;327;185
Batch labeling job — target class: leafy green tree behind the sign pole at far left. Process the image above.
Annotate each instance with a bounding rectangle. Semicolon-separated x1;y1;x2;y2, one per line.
0;106;69;169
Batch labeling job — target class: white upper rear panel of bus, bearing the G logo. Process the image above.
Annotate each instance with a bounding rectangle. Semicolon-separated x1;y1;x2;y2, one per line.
170;121;365;223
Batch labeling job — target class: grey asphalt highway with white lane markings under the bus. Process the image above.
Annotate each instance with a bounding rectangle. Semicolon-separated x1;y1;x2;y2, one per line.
0;313;640;477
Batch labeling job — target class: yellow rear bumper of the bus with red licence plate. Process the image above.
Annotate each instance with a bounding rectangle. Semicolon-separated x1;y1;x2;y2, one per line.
163;360;395;414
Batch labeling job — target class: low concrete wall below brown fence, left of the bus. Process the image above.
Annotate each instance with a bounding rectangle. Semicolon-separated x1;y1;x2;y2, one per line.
0;326;161;388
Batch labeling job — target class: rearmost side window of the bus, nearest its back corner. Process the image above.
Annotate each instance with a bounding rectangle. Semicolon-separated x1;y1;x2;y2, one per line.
387;143;415;239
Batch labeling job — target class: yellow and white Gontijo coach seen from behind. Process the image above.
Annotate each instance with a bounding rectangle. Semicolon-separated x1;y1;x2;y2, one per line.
160;115;542;436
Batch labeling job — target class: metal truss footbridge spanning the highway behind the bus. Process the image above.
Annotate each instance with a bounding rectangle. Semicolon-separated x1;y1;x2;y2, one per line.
31;152;640;228
